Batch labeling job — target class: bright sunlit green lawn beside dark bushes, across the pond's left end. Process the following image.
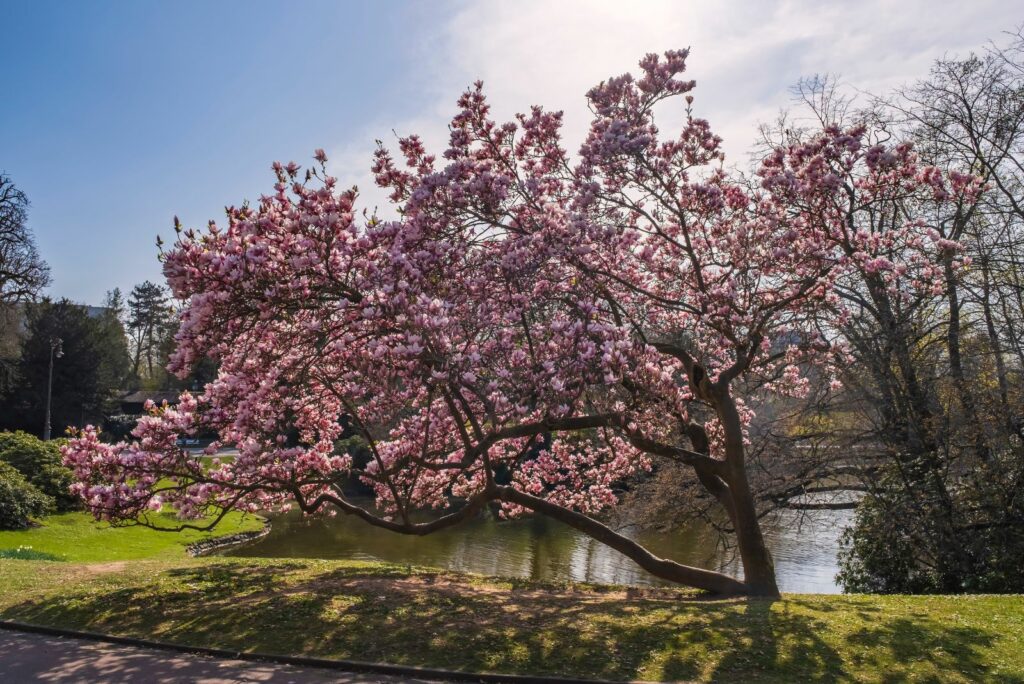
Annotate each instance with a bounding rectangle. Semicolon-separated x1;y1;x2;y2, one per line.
0;512;263;562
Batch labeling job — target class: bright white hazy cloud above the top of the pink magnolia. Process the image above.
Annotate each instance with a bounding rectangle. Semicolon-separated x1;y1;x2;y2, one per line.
332;0;1024;208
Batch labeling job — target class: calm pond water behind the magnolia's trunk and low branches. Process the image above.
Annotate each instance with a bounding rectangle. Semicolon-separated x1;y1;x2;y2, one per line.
225;501;852;593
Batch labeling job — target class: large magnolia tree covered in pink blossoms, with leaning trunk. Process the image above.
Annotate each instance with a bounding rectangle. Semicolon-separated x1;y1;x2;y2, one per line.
65;51;968;596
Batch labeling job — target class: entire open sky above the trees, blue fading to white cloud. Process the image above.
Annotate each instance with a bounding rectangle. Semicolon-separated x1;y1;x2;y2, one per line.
0;0;1024;303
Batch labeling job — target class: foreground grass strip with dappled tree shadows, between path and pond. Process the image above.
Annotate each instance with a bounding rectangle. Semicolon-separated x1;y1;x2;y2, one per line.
0;558;1024;682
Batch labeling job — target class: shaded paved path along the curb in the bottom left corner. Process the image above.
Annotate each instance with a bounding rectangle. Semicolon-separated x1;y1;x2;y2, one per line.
0;630;440;684
